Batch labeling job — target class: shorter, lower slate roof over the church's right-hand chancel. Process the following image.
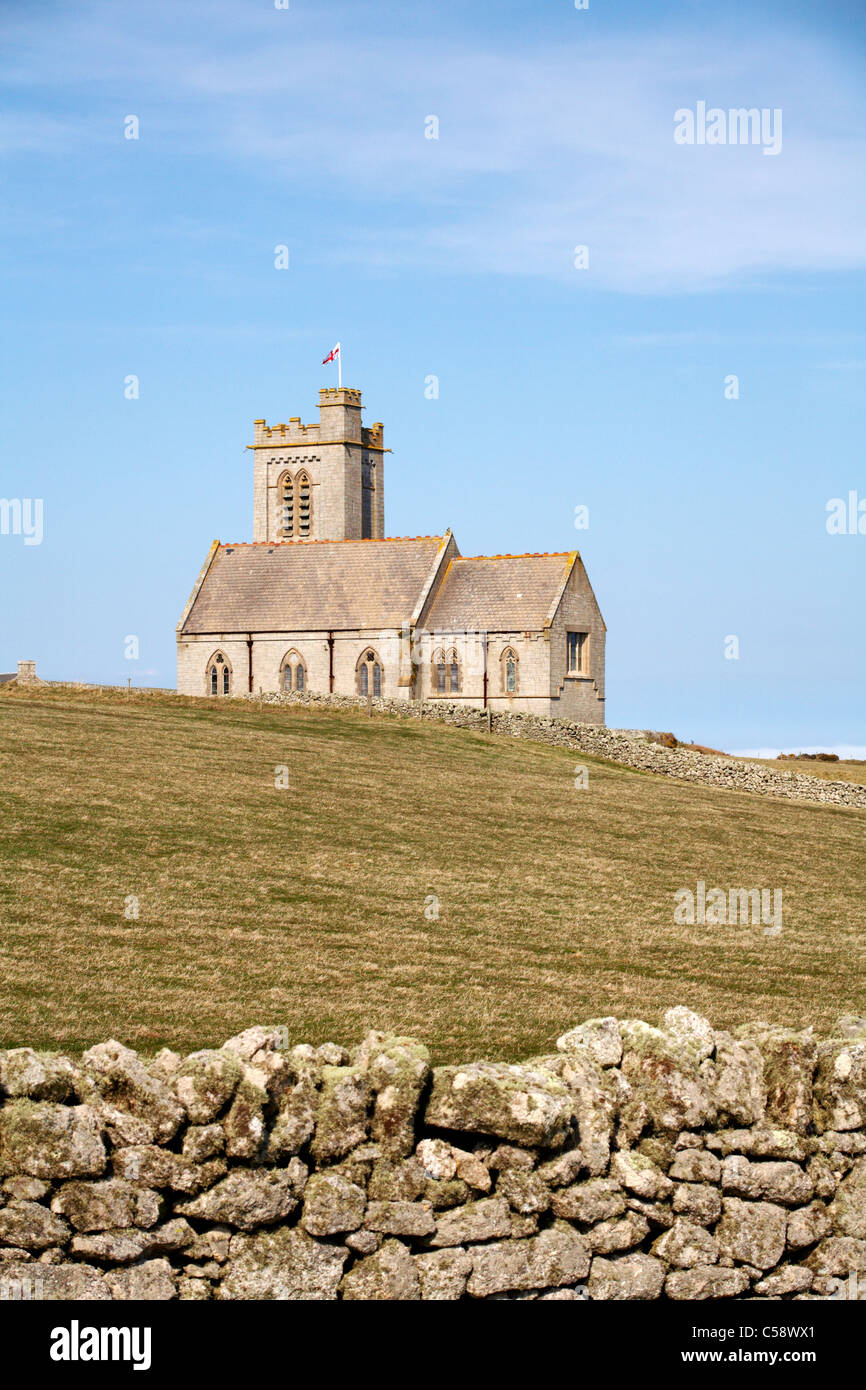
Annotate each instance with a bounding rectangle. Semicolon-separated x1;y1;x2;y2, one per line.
425;550;575;632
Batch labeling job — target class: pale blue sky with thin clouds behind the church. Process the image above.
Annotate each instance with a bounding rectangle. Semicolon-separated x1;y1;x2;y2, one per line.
0;0;866;749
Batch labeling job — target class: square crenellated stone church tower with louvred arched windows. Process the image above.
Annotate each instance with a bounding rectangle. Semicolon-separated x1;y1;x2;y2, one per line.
247;386;388;541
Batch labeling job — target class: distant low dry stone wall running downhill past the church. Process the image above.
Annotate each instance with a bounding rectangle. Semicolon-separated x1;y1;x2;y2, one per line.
243;692;866;806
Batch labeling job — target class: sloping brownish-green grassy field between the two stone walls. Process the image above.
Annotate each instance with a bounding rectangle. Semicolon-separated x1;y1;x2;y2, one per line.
0;688;866;1061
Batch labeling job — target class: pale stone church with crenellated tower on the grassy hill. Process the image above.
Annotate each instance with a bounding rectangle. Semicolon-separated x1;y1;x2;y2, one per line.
177;386;605;724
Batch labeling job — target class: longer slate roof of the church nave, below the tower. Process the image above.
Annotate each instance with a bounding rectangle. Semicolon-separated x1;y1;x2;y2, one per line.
181;535;443;634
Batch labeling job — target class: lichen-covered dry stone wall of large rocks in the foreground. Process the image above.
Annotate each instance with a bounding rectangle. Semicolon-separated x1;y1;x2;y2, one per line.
0;1008;866;1300
